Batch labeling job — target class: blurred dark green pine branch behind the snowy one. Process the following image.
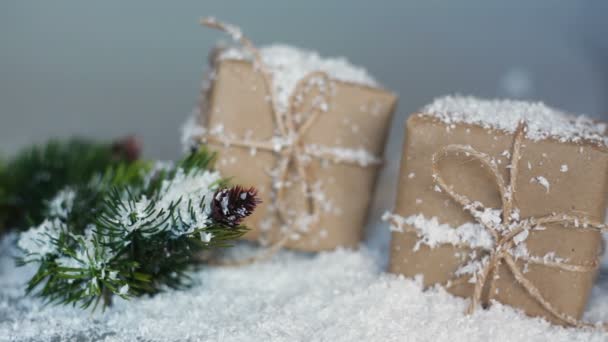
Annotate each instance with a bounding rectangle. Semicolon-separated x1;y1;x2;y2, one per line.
0;138;139;230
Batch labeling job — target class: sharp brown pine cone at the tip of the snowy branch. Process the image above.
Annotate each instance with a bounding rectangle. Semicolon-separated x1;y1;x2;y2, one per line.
211;186;262;227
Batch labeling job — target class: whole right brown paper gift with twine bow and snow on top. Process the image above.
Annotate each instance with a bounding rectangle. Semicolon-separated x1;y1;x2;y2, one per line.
384;97;608;326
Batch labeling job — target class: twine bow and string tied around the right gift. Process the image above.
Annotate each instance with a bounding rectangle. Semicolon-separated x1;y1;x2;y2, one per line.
393;122;608;327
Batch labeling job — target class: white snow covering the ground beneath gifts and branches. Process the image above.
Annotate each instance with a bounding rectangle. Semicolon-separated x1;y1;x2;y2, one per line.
0;234;608;342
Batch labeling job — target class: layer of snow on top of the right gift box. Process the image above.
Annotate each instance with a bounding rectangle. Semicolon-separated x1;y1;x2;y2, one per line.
421;96;608;146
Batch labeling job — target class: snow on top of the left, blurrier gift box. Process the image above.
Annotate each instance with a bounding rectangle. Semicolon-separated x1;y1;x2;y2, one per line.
219;44;378;112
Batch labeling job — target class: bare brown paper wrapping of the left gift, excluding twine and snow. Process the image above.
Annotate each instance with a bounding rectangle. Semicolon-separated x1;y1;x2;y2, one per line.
200;59;396;251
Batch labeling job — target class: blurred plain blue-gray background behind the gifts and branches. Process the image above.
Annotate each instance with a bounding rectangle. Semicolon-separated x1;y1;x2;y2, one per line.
0;0;608;248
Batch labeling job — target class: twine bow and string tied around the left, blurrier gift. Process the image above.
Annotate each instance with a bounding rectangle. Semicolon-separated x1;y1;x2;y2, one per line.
201;18;382;265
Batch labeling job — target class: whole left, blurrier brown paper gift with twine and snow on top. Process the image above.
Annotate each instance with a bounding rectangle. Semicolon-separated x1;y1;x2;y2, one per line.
184;19;396;251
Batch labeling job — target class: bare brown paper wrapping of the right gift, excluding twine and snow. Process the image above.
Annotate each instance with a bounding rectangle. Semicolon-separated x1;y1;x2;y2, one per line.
389;115;608;324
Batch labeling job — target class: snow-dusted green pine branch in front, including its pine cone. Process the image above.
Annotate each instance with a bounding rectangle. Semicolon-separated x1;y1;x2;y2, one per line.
18;150;259;308
